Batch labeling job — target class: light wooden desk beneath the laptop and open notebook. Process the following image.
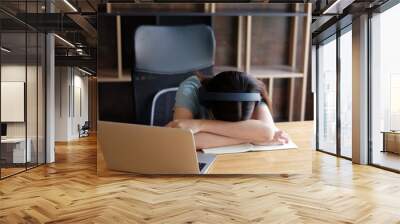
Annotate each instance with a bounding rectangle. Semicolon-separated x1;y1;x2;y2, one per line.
97;121;313;176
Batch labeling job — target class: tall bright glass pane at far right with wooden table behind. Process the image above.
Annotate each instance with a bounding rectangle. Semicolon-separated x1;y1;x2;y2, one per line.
371;4;400;170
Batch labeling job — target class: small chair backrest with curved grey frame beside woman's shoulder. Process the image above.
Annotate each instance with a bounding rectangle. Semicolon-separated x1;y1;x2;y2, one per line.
150;87;178;126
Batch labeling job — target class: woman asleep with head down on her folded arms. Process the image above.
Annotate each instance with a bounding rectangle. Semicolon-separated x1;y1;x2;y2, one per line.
167;71;288;149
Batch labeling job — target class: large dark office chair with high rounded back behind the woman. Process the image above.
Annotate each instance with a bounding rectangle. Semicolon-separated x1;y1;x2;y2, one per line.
132;25;215;124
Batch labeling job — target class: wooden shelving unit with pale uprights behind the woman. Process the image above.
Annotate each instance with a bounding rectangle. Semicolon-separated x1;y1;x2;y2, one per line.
205;3;311;121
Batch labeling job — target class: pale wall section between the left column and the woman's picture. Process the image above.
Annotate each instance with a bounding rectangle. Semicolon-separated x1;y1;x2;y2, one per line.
55;67;89;141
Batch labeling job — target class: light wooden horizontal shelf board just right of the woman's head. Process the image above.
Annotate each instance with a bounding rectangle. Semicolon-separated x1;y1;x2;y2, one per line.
249;66;303;79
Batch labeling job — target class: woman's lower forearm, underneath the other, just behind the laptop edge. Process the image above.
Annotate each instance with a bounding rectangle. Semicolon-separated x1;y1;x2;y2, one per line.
194;132;248;149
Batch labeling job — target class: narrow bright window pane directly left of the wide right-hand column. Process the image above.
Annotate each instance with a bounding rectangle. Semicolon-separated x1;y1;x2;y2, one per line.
340;31;353;158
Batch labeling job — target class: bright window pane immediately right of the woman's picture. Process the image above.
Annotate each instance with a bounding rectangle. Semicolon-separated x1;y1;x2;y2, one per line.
317;38;336;153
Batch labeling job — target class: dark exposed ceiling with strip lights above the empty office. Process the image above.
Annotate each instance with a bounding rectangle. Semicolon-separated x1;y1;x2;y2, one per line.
0;0;394;72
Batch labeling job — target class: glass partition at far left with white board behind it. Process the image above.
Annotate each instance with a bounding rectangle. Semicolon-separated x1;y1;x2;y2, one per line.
0;0;46;178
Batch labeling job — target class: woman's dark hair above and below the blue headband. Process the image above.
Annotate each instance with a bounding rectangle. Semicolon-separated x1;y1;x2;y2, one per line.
202;71;271;121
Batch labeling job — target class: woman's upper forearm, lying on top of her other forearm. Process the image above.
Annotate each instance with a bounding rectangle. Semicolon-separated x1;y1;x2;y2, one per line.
200;120;275;143
